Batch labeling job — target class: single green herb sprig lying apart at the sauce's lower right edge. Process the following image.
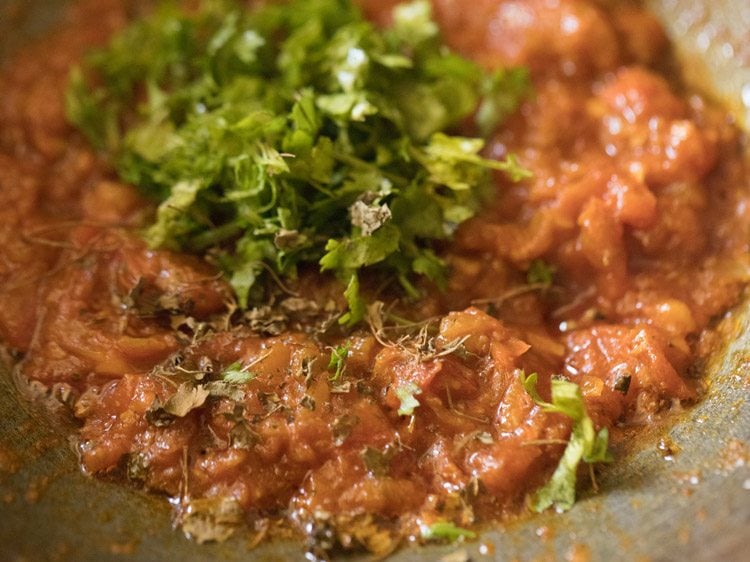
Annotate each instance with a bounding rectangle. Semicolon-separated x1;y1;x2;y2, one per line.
521;372;613;512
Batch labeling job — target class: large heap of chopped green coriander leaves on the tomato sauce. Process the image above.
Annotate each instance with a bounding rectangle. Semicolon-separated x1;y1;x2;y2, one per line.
66;0;529;316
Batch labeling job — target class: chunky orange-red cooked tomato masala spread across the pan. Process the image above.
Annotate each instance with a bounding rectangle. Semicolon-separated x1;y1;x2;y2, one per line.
0;0;750;553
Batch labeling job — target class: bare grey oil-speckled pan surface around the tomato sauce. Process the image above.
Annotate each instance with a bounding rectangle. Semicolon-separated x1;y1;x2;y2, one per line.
0;0;750;562
